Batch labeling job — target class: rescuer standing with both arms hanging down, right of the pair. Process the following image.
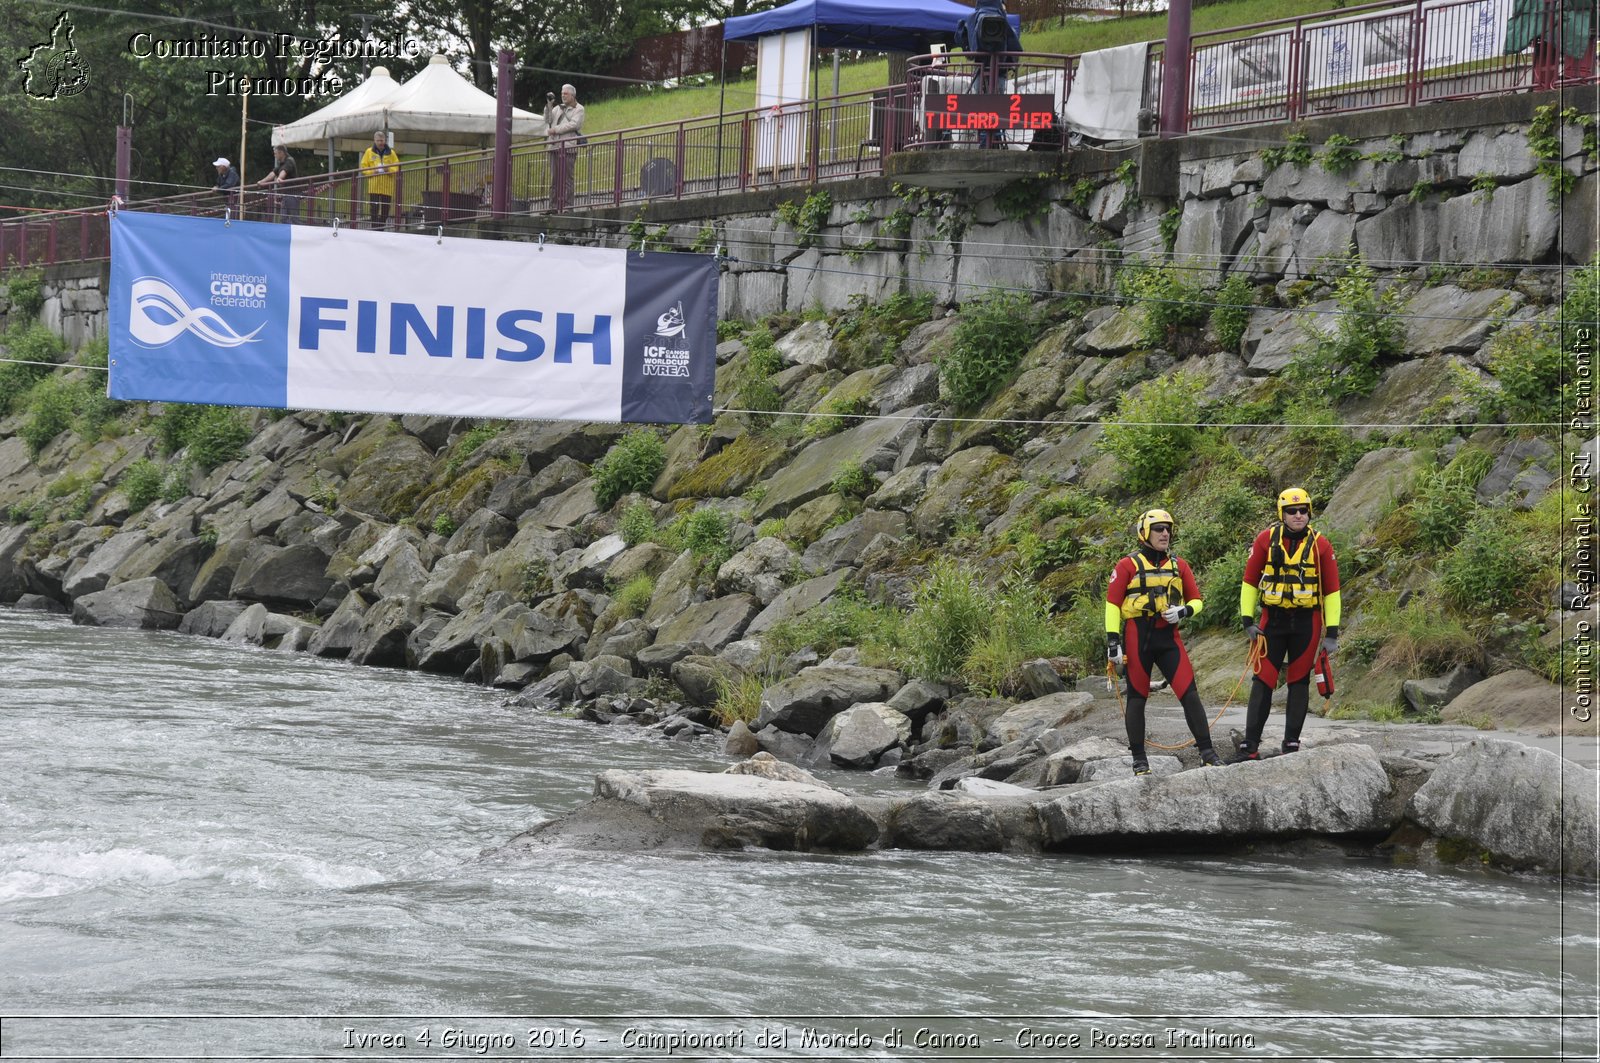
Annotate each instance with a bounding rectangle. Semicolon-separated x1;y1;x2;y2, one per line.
1237;487;1339;760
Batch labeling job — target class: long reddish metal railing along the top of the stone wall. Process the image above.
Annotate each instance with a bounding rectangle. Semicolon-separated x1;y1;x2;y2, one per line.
0;0;1597;269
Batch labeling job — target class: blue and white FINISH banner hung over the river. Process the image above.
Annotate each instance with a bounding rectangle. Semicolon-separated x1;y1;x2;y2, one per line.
110;211;717;424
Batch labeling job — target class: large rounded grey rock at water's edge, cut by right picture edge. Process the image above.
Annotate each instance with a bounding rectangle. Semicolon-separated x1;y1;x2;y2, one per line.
1406;738;1600;880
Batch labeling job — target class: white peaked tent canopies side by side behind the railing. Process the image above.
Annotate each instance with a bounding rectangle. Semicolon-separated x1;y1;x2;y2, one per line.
272;56;544;154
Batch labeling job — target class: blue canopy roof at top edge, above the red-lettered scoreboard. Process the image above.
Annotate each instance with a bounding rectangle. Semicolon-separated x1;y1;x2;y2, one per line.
722;0;1021;51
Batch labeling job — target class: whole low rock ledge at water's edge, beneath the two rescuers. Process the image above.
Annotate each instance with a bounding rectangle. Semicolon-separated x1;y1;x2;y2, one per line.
509;732;1600;880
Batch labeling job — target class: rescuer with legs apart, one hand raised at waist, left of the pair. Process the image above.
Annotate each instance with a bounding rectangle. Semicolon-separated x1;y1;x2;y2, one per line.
1106;509;1221;775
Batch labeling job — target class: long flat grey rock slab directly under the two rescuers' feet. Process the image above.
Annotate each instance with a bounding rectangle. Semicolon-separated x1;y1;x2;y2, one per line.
1038;746;1400;850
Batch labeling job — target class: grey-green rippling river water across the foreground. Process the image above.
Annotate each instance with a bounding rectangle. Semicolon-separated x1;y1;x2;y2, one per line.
0;610;1600;1060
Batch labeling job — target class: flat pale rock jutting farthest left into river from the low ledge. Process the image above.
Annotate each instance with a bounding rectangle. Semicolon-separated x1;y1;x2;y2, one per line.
512;772;878;852
